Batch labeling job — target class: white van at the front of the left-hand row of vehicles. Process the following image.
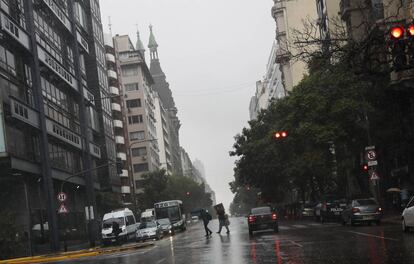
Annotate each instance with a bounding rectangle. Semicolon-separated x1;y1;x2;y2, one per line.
102;208;137;245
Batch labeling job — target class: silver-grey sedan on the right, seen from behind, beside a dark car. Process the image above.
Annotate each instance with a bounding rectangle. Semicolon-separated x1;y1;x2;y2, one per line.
342;198;382;225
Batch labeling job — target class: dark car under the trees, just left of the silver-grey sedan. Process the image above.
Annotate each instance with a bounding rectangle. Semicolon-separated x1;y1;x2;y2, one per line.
314;195;346;223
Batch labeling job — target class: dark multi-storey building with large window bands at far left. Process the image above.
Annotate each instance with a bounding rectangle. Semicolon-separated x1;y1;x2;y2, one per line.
0;0;120;250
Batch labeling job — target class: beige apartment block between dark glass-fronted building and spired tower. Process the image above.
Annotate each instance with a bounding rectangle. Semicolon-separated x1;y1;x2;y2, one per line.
114;35;160;192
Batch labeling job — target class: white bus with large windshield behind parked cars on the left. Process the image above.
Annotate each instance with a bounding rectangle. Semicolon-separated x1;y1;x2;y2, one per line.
154;200;187;231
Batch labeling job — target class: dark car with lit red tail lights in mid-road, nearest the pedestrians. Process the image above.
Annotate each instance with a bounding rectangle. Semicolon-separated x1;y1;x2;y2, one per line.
247;206;279;235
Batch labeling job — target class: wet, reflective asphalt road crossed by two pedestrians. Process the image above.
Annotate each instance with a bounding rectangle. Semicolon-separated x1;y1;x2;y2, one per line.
55;218;414;264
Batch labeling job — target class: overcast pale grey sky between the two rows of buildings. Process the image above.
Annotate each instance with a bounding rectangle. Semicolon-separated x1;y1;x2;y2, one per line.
100;0;275;208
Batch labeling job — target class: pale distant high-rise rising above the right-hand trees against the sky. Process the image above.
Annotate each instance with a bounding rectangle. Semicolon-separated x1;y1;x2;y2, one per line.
249;42;286;120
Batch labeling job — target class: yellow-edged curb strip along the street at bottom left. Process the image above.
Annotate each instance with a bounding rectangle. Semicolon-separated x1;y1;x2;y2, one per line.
0;242;154;264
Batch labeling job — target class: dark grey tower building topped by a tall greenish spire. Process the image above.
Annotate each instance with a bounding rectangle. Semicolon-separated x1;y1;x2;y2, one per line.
148;26;182;175
